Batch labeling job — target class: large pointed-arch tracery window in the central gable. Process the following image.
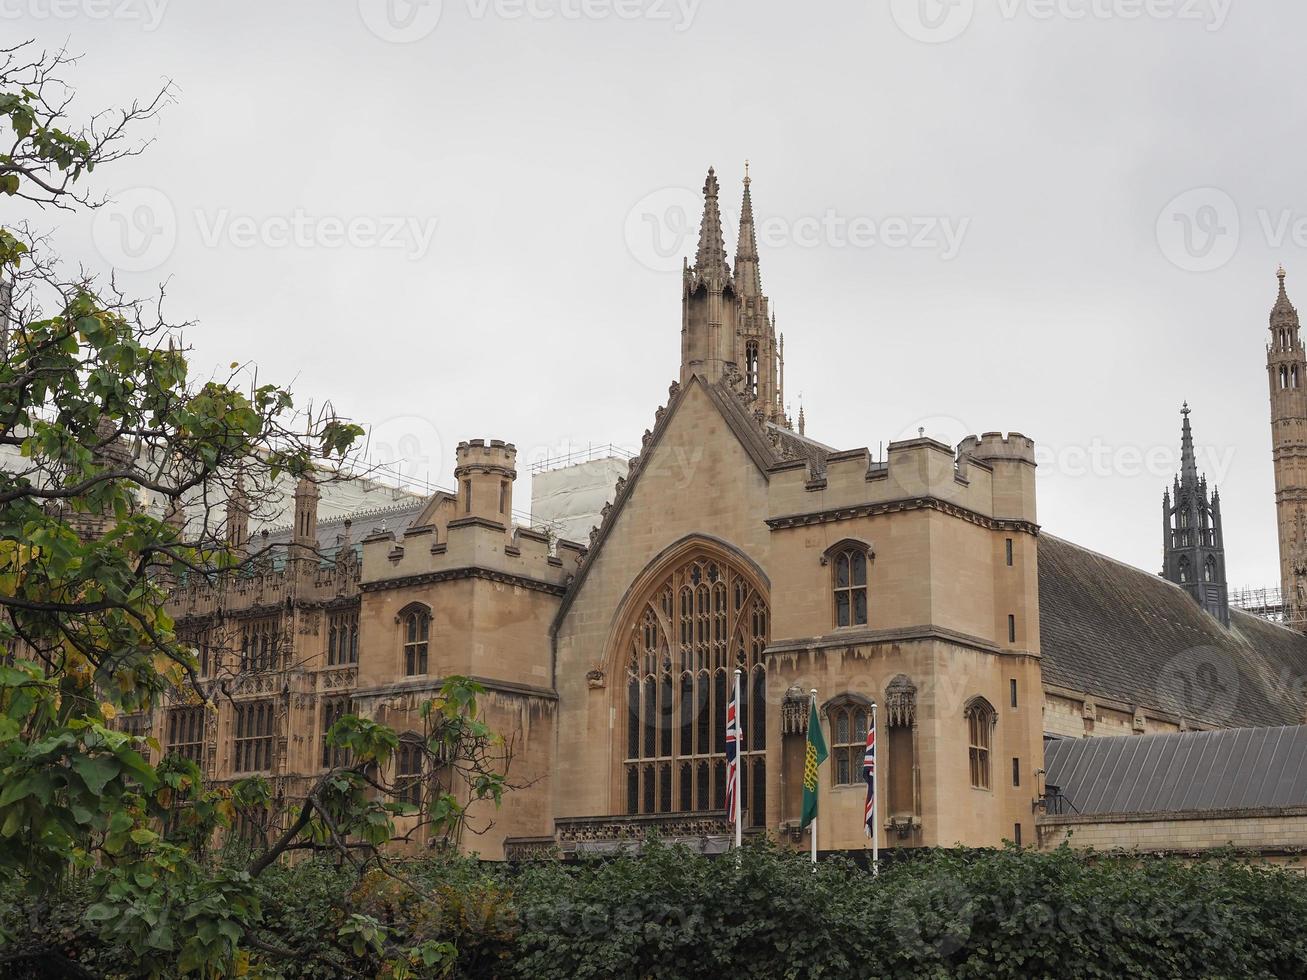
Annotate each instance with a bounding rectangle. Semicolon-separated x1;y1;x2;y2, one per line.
621;554;770;826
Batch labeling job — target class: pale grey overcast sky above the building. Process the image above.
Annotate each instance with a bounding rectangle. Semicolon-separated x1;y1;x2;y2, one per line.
0;0;1307;585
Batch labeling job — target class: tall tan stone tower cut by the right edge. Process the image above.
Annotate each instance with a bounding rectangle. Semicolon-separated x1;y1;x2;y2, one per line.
1266;267;1307;626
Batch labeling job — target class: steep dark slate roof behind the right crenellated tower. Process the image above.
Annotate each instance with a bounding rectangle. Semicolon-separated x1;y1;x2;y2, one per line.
1039;533;1307;728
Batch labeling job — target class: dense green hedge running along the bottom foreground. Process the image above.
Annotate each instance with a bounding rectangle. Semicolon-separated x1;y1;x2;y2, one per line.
0;841;1307;980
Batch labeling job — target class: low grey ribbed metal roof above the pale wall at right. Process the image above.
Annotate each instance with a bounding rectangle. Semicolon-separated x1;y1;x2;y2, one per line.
1044;727;1307;814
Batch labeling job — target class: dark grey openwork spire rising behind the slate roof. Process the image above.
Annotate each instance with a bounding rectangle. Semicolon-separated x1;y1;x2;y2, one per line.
1162;402;1230;626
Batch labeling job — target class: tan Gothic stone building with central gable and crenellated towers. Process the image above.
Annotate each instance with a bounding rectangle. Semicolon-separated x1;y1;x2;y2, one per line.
131;170;1307;858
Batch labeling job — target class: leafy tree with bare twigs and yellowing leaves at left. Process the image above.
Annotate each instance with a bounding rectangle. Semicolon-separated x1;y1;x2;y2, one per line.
0;44;505;976
